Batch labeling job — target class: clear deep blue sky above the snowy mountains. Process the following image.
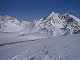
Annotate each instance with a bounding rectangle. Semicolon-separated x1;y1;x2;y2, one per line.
0;0;80;18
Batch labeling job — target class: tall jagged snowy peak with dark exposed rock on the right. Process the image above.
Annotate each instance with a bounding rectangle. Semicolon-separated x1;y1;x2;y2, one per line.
36;12;80;36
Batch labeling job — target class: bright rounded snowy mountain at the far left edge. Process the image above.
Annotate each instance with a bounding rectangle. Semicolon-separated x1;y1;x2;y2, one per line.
0;16;21;32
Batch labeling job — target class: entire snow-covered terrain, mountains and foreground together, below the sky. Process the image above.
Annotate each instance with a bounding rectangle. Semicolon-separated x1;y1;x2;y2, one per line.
0;12;80;60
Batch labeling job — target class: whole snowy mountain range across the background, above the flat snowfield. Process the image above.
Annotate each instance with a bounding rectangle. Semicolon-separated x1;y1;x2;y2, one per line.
0;12;80;36
